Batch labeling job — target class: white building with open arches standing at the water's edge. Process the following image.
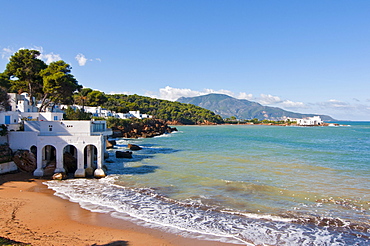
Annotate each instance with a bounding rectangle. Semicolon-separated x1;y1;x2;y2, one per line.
8;121;112;177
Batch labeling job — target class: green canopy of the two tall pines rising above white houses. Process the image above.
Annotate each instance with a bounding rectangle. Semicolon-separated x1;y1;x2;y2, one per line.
0;49;82;111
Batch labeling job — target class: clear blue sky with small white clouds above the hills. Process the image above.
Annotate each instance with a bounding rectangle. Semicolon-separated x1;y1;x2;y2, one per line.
0;0;370;120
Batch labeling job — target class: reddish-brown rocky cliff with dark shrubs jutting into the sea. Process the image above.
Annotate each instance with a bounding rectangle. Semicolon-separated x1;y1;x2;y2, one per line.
112;119;177;138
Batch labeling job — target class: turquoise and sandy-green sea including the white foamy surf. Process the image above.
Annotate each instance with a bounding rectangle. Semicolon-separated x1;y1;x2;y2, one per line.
46;122;370;245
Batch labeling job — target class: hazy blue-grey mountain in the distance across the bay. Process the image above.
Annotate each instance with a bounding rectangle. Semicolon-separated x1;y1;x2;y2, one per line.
177;94;334;121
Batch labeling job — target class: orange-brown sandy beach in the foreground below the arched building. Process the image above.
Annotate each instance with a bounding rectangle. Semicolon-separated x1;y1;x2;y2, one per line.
0;172;234;246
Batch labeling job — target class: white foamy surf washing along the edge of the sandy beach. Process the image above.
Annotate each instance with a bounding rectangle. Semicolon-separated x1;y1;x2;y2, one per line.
45;175;367;245
